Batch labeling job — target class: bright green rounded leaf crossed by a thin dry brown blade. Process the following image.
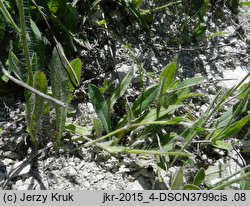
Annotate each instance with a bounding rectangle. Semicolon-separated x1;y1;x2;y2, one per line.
66;58;82;91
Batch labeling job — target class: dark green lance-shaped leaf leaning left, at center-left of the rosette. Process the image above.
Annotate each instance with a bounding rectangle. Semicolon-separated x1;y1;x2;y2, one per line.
89;84;111;133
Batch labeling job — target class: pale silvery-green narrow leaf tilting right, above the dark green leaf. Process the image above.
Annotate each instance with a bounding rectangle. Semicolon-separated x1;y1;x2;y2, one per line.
109;67;134;110
